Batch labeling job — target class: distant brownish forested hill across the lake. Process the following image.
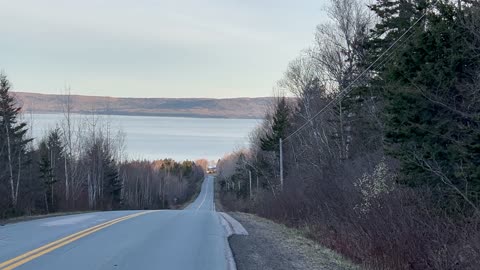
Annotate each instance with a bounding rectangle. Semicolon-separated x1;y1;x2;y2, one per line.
14;92;272;118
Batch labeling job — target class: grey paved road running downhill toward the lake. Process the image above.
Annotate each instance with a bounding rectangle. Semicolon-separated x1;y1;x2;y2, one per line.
0;176;239;270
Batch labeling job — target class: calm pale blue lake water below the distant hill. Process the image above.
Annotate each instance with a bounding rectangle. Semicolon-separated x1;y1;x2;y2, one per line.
24;114;260;160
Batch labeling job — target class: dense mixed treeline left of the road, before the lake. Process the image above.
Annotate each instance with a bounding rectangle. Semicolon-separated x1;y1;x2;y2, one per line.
0;74;205;219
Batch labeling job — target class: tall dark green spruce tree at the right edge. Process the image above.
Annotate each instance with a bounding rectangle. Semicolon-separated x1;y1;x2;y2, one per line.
371;0;480;209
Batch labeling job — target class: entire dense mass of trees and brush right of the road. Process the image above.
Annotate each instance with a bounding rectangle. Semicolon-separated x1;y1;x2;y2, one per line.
218;0;480;269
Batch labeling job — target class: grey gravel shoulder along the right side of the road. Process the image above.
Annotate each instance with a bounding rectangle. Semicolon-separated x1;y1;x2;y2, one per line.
229;212;359;270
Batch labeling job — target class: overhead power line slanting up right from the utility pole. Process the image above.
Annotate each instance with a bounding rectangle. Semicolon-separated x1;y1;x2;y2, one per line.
283;0;439;141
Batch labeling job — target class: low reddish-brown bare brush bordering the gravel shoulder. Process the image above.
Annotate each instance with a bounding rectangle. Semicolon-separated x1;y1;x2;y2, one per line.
219;149;480;270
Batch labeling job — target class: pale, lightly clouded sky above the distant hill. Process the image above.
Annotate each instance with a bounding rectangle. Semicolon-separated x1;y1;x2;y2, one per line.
0;0;326;98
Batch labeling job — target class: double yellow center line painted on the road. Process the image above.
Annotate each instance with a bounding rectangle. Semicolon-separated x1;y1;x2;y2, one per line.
0;211;151;270
